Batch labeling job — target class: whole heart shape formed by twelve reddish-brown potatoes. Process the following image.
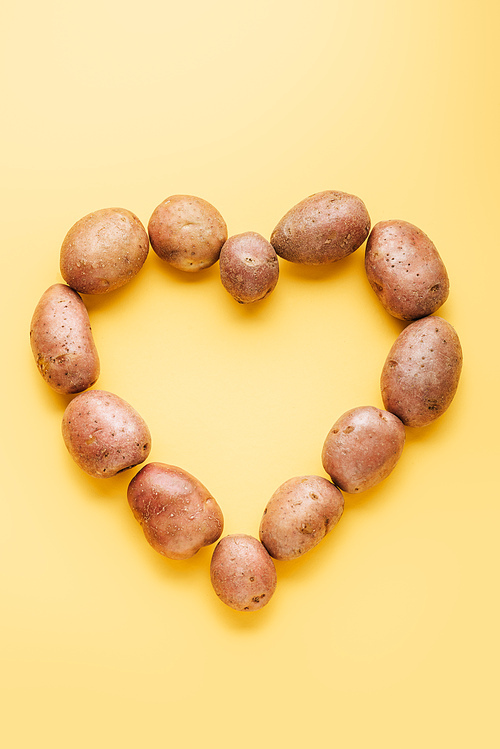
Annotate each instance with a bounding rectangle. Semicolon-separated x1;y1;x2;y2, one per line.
30;190;462;611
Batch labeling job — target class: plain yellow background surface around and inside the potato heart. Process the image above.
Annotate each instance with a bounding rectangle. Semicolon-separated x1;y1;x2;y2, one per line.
0;0;500;749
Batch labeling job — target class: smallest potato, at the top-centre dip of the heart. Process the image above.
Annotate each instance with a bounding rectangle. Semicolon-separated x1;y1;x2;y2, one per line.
219;231;279;304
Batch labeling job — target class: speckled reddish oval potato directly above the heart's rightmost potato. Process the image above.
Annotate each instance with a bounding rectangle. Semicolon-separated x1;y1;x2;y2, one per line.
365;221;450;320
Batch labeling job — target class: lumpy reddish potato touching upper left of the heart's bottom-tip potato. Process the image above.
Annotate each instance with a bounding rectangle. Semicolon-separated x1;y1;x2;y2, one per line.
127;463;224;559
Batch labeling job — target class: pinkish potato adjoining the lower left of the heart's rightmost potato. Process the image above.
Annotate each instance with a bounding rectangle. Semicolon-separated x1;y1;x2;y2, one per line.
322;406;406;494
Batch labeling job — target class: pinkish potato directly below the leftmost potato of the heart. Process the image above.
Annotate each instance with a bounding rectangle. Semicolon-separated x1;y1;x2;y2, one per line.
62;390;151;478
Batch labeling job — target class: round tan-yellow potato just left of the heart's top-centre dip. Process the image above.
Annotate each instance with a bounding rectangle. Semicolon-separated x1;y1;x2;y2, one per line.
148;195;227;272
